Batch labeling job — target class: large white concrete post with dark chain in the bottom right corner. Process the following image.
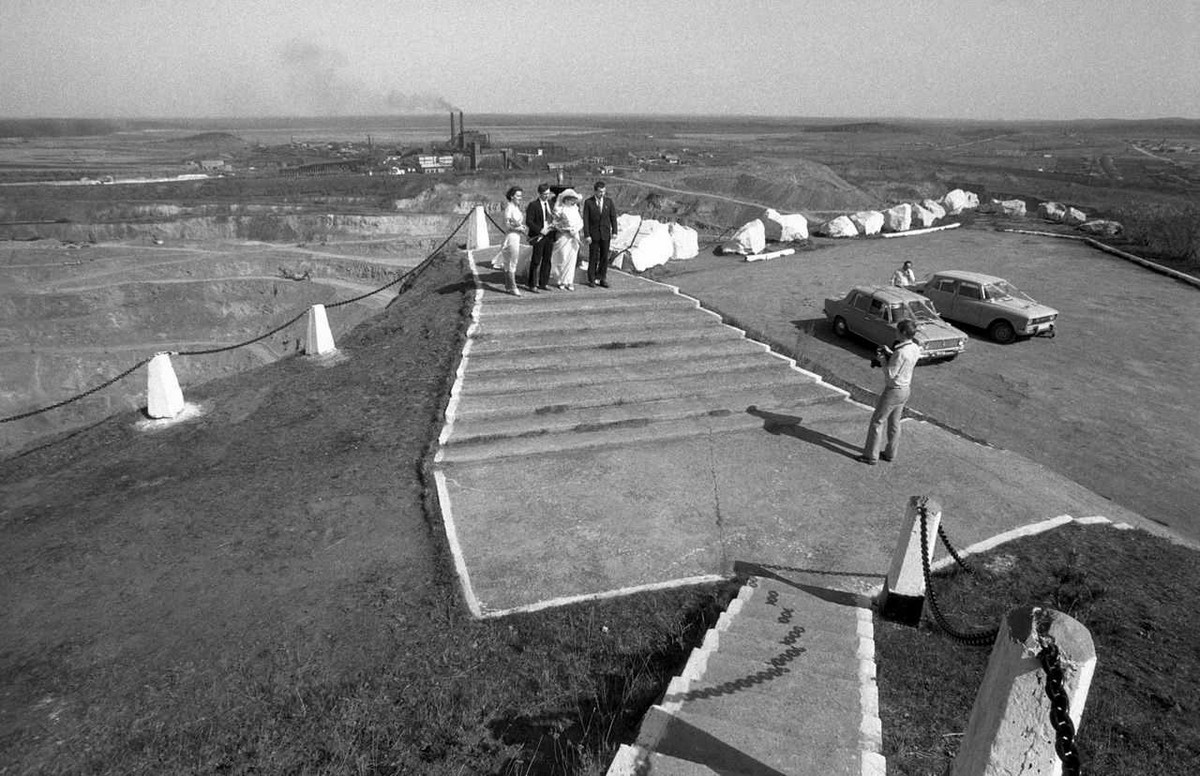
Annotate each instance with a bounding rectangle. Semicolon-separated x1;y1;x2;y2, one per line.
952;607;1096;776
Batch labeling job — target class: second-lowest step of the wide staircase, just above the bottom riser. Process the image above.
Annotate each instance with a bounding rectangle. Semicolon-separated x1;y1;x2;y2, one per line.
446;383;840;445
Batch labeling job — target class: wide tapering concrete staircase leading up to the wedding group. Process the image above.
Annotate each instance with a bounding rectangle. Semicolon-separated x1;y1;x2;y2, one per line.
438;276;846;465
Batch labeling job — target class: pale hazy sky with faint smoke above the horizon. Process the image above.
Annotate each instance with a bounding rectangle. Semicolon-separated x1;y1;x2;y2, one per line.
0;0;1200;120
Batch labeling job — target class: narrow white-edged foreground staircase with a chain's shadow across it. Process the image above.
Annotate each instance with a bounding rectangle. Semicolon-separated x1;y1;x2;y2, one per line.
608;577;887;776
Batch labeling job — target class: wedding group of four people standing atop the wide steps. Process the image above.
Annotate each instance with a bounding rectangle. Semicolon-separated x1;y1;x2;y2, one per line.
493;181;617;296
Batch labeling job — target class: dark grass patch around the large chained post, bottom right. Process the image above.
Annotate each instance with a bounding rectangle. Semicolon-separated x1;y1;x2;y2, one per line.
876;525;1200;776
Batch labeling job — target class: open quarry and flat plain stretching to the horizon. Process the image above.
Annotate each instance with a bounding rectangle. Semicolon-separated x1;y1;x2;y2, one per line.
0;114;1200;455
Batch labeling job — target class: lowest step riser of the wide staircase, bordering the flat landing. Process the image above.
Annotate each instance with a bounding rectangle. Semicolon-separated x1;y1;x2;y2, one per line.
438;413;762;464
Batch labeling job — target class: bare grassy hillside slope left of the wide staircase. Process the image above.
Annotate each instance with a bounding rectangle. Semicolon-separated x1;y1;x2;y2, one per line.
0;257;466;772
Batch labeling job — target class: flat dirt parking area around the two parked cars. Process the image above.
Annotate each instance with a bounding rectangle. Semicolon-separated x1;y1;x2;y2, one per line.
652;221;1200;539
